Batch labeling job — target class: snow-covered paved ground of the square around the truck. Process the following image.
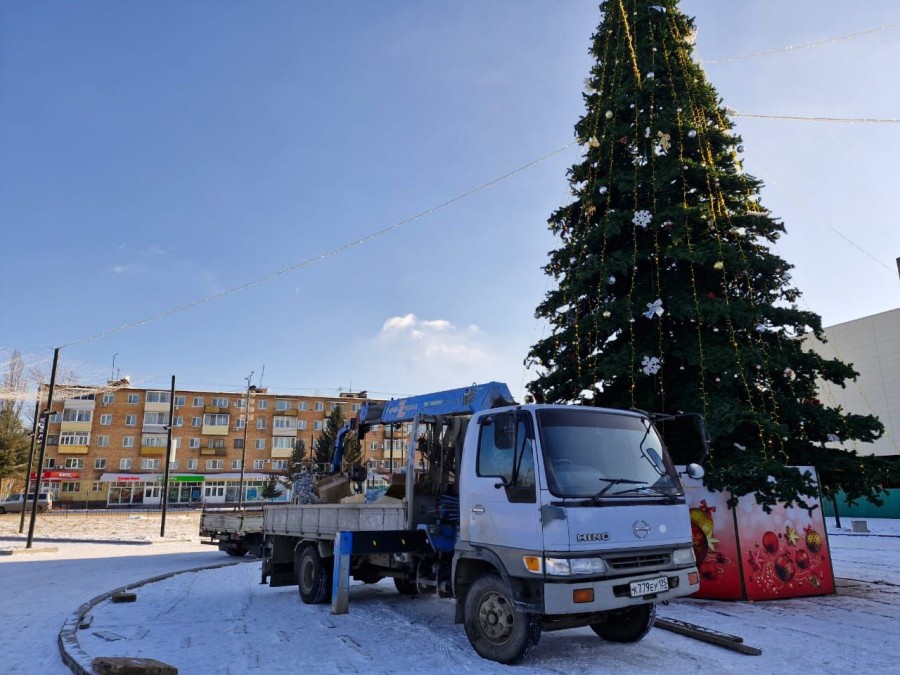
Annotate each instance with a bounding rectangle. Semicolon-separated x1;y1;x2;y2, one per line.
0;513;900;675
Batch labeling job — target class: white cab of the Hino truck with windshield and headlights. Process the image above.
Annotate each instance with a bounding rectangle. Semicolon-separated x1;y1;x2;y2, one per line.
453;405;699;649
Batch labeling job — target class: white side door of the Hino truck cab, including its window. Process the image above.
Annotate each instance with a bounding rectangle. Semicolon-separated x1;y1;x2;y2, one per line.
460;411;543;557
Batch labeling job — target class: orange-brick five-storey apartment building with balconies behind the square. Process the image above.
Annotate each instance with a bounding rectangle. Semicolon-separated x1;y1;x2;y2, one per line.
32;381;406;507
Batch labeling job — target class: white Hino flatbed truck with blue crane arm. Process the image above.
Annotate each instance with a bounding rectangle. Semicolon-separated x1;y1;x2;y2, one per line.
262;382;706;663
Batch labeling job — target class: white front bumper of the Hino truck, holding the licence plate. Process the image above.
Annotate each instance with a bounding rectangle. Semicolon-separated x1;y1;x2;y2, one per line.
544;567;700;614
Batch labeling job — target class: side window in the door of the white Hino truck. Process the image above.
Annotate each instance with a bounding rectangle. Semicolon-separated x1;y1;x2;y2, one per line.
476;415;537;502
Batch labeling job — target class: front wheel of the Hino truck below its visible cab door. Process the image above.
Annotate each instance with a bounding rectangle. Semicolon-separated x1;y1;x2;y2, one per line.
464;573;541;664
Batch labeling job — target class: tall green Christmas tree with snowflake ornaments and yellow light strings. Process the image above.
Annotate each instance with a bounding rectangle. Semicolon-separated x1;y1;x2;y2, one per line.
527;0;885;507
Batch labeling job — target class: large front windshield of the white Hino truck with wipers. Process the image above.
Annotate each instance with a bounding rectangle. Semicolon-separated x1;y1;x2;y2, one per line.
537;408;684;501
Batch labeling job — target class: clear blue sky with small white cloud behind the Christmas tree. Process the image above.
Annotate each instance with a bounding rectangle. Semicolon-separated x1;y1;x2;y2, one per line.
0;0;900;396
